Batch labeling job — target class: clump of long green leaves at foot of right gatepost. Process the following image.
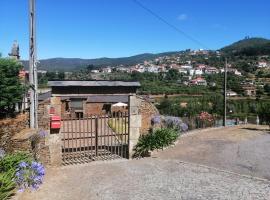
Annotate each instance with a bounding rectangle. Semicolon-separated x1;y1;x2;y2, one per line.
133;128;179;157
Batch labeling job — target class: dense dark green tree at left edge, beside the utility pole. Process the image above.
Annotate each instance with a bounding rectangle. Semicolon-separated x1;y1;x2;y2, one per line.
0;59;24;117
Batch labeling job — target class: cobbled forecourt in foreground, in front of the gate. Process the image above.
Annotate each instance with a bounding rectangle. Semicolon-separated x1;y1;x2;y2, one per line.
18;158;270;200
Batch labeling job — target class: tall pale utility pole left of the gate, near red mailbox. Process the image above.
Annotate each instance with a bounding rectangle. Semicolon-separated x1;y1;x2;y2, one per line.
29;0;38;129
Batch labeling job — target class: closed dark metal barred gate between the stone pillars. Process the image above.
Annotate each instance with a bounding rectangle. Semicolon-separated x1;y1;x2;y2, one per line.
61;112;129;164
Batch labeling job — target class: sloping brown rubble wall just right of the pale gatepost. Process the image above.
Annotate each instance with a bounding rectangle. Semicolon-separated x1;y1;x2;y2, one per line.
138;96;159;134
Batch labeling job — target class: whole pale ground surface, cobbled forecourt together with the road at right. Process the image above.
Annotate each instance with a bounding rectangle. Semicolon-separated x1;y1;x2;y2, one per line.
17;124;270;200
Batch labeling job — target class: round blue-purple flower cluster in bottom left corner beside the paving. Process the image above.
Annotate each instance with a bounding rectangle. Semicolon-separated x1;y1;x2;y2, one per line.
15;161;45;191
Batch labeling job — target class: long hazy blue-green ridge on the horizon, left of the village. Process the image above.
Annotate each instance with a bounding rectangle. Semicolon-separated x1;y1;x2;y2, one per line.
23;51;179;71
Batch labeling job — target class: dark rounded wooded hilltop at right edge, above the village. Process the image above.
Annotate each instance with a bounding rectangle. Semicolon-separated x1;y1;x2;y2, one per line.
221;38;270;56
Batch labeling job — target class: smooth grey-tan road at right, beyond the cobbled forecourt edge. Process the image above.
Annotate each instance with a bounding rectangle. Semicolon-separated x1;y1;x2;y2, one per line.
155;125;270;180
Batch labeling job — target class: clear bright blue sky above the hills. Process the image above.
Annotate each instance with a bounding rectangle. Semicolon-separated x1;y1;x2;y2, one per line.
0;0;270;59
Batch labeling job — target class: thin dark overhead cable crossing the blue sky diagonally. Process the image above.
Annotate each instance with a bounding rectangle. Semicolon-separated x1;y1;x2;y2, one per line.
132;0;209;49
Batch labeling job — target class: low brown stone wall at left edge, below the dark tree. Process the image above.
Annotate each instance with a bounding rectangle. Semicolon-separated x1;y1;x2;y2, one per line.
0;113;29;152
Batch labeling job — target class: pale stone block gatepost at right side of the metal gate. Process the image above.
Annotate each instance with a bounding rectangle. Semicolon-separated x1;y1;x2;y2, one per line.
129;96;142;158
